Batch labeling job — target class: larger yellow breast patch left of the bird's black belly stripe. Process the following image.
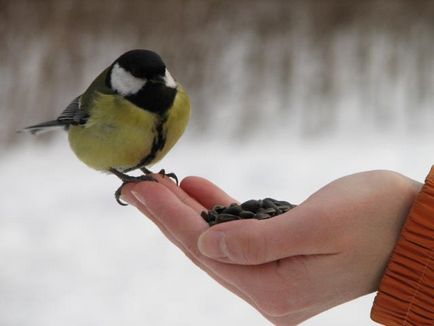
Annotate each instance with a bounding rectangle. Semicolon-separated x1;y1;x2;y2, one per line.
68;94;157;170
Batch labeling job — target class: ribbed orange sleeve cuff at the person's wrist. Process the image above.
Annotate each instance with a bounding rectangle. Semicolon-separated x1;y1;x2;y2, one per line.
371;166;434;326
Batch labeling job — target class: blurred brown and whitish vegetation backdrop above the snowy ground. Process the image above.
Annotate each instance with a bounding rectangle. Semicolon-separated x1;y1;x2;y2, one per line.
0;0;434;147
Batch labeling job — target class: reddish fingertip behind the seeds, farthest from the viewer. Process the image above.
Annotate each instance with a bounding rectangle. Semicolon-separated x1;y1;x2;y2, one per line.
180;177;237;209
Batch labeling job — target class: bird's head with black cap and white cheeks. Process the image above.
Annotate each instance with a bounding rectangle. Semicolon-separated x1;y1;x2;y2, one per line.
106;50;176;97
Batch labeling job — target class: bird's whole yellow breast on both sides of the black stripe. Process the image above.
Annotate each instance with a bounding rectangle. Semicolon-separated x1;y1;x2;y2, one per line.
68;87;190;171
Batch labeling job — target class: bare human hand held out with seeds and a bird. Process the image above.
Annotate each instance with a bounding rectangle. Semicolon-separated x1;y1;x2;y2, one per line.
123;171;421;325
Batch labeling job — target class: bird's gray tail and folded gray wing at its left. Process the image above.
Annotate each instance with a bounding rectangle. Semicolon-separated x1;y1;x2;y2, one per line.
24;96;89;134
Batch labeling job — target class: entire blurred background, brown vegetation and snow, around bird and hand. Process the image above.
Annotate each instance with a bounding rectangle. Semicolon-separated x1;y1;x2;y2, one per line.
0;0;434;325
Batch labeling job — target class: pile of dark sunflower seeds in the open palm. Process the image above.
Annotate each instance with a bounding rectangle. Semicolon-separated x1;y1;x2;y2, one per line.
201;198;296;226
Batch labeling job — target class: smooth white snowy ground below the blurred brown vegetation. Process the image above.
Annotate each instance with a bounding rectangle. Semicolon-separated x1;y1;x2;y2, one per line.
0;131;434;326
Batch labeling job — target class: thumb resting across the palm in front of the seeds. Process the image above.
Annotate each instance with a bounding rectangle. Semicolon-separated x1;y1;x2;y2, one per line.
198;205;339;265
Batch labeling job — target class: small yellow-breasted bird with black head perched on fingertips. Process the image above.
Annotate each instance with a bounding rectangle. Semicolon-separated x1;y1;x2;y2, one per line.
23;49;190;205
